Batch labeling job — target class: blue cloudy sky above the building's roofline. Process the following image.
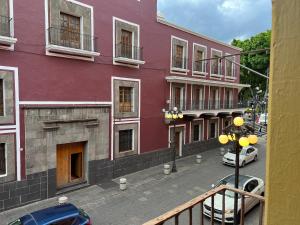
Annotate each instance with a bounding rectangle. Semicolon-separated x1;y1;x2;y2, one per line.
158;0;272;43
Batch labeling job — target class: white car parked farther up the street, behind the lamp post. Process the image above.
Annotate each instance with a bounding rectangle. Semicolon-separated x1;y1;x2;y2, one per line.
222;145;258;167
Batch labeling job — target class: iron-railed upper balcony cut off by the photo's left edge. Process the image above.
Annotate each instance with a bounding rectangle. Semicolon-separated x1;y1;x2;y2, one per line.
0;15;17;45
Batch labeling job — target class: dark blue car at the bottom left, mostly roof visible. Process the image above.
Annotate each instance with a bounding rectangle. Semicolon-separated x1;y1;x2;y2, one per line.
8;203;92;225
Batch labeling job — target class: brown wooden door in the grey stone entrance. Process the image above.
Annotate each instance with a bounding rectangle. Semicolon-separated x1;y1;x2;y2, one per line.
56;142;85;188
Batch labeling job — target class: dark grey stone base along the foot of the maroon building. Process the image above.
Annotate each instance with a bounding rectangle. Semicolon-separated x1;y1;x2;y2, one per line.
0;139;220;211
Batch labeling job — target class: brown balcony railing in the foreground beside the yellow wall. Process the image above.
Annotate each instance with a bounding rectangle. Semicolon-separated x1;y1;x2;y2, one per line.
143;185;265;225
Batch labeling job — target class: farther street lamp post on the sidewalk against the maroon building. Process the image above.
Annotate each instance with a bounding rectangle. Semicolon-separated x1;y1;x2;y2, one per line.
163;107;183;173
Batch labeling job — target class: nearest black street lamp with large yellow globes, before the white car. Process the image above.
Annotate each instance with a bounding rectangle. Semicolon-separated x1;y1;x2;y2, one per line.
219;117;257;225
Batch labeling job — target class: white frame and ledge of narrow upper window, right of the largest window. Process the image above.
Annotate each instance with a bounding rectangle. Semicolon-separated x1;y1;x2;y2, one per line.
112;16;145;69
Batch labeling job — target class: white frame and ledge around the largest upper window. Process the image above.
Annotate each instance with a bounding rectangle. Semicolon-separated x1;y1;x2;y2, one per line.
44;0;100;61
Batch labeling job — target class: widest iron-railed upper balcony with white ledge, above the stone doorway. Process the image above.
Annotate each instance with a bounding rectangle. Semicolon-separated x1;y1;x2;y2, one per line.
46;27;100;57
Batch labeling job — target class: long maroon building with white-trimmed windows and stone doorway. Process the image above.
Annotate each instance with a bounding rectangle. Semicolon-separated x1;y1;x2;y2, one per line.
0;0;249;210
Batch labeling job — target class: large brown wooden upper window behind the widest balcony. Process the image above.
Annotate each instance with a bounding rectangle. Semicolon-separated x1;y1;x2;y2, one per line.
60;12;80;49
